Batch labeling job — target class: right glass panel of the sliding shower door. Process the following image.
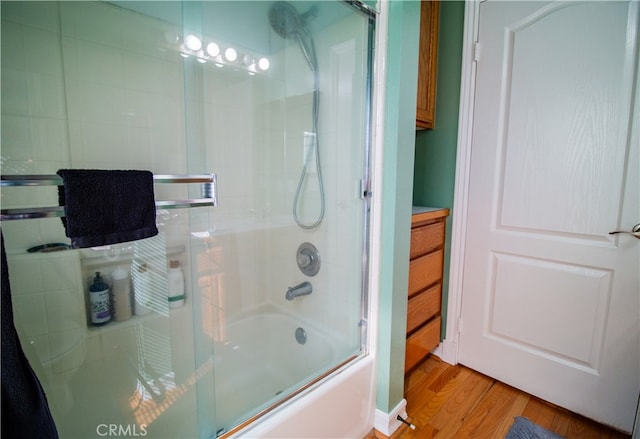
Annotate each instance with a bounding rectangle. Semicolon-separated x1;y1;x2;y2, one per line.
182;1;373;434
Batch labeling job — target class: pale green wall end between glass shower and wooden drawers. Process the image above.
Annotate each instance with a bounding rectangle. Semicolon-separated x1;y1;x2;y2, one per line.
376;1;420;413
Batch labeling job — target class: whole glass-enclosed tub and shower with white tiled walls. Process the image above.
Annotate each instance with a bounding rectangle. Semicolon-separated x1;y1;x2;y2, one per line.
1;1;375;438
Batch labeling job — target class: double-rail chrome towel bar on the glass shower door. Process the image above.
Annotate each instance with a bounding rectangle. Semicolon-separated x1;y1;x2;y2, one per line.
0;174;218;221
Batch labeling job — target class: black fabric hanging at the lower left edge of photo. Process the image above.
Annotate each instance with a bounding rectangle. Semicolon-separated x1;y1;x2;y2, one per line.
0;231;58;439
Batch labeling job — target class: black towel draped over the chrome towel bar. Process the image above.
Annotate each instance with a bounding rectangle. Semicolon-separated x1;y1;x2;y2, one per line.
58;169;158;248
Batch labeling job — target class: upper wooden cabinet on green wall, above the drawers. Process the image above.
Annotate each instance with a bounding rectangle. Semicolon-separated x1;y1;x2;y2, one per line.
416;1;440;129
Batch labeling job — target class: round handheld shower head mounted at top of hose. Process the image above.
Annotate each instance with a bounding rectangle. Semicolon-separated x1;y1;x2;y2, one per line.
269;1;317;73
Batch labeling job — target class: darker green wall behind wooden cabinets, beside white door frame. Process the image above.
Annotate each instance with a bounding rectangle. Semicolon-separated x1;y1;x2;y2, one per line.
413;1;464;337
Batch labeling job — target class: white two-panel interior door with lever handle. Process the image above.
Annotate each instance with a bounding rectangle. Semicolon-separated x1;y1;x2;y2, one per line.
458;1;640;432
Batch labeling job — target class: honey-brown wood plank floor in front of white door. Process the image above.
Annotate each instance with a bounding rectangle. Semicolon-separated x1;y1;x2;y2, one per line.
363;355;629;439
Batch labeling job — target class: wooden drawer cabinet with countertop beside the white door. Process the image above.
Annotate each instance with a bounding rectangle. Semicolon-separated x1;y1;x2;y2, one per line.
404;207;449;373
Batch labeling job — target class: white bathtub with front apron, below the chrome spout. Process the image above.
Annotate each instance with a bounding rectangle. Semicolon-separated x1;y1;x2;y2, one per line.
213;312;375;438
